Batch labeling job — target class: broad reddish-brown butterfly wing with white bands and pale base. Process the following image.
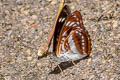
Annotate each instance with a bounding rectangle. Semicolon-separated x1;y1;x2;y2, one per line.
56;11;91;62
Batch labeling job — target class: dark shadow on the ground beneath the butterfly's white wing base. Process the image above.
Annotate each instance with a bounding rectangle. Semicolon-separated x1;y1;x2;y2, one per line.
49;56;89;74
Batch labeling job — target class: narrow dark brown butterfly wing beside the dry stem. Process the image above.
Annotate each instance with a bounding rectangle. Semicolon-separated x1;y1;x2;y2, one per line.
53;5;71;52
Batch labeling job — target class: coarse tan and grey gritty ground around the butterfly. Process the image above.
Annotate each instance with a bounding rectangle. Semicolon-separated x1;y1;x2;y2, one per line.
0;0;120;80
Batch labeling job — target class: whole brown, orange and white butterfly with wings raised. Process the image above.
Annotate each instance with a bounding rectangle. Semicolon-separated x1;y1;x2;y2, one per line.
49;5;91;62
